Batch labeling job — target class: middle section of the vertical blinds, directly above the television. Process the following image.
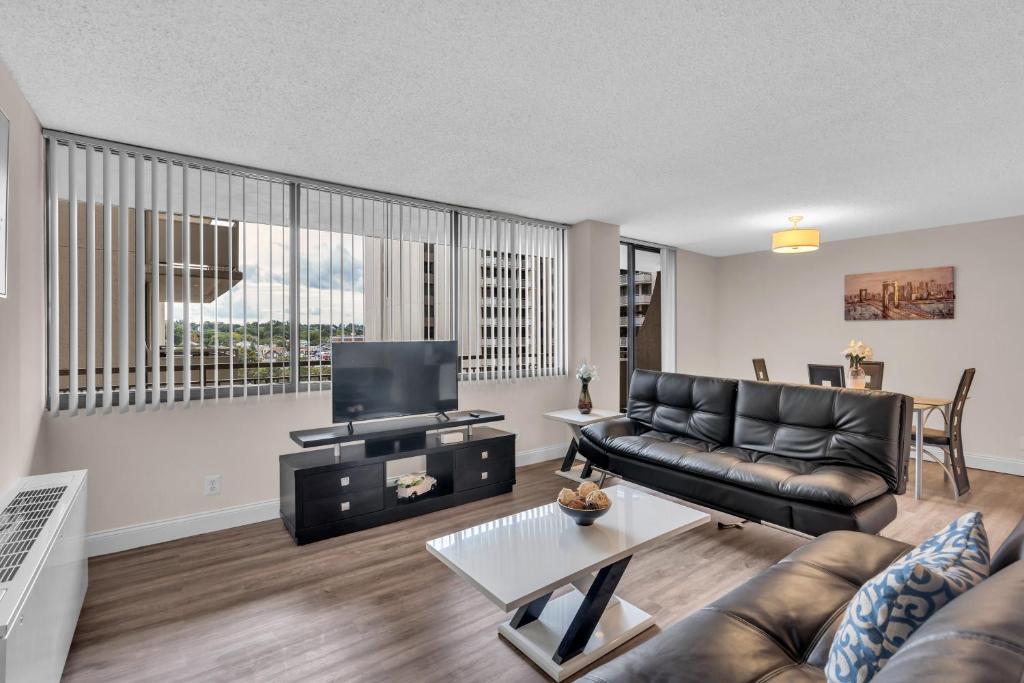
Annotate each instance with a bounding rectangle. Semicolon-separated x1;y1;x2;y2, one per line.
296;186;454;390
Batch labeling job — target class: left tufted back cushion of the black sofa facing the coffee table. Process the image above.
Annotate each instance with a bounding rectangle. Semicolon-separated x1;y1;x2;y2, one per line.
626;370;737;445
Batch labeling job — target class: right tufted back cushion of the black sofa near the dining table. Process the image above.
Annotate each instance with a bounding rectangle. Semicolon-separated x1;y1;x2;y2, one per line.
733;380;913;493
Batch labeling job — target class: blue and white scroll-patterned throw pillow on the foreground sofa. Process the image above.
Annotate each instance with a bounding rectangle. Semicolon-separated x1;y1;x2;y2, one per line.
825;512;988;683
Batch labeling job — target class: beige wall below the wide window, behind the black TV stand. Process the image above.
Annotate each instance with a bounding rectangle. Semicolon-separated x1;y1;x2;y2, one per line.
45;378;571;531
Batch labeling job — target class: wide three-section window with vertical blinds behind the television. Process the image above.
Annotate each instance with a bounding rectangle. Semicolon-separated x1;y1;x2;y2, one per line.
46;131;565;413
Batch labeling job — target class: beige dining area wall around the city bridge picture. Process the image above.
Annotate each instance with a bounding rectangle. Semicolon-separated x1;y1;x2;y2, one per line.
679;216;1024;470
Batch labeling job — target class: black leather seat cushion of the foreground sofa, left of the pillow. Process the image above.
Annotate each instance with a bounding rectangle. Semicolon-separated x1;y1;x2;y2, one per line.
583;531;907;683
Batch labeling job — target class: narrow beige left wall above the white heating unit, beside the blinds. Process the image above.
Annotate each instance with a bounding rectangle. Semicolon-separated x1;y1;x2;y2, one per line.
0;57;46;490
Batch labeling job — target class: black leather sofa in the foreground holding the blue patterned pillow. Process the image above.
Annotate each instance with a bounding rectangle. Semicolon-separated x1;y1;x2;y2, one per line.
581;521;1024;683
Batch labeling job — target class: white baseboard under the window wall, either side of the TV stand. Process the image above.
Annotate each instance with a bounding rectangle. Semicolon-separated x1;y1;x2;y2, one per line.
86;443;565;557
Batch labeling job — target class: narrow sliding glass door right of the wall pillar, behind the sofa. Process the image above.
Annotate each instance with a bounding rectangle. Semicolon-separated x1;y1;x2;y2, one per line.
618;242;663;411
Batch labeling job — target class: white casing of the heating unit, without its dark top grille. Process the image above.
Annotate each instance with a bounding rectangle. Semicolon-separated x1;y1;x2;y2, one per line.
0;470;89;683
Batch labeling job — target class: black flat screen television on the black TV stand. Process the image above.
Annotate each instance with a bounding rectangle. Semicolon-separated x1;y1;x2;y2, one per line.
331;341;459;422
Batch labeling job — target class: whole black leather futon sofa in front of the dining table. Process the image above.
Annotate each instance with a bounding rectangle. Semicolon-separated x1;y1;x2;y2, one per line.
580;370;913;536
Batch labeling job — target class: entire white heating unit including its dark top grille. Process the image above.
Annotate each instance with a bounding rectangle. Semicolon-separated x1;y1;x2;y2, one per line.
0;470;89;683
